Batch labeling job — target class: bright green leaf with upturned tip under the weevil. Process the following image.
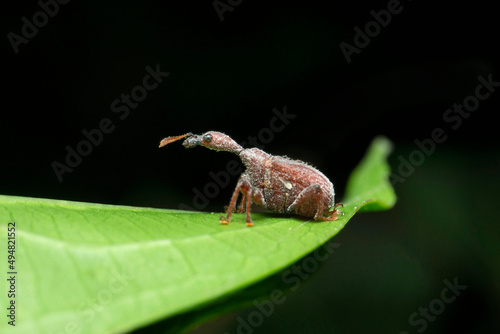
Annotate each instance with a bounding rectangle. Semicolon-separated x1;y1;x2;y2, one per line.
0;138;396;333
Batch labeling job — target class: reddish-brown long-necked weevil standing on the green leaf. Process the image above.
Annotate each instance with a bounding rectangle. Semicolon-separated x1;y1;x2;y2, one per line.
160;131;343;226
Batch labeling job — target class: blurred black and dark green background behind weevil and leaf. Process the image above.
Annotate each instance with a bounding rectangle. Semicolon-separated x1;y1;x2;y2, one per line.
0;0;500;333
